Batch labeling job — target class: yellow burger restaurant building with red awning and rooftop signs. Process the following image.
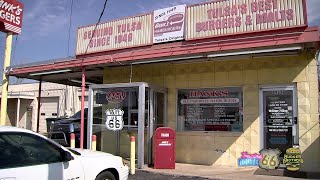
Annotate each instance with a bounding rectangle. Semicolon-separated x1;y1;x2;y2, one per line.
11;0;320;172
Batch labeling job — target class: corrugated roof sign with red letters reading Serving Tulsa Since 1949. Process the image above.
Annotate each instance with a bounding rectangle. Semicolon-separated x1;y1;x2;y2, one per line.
76;14;152;55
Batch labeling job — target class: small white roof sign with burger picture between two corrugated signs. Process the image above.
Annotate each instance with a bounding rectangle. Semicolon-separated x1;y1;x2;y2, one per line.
153;5;186;43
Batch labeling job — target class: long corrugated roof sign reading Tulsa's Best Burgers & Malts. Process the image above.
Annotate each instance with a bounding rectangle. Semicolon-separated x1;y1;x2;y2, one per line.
186;0;307;40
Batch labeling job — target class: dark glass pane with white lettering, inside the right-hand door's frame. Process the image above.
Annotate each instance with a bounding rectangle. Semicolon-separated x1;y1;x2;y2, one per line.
263;90;293;155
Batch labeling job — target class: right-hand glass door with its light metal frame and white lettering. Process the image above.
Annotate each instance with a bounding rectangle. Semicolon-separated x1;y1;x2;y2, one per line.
260;86;298;157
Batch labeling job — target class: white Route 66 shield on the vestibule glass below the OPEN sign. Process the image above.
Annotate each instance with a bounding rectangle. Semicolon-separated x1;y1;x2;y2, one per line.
106;109;124;131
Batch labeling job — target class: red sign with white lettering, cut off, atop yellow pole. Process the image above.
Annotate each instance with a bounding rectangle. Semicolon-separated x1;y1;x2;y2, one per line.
0;0;23;34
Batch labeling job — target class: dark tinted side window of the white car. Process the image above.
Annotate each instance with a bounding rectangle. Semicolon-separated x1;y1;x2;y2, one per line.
0;132;63;169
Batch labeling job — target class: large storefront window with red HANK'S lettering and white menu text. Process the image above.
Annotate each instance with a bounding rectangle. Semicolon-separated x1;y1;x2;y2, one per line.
177;87;243;132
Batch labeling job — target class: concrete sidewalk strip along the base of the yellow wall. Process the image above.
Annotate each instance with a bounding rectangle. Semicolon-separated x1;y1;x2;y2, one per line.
143;163;312;180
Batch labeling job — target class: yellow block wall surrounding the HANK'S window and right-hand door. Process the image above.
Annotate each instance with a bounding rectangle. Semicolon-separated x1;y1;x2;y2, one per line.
104;53;320;171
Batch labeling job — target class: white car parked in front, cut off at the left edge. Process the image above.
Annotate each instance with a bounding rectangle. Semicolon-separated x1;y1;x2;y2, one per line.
0;126;129;180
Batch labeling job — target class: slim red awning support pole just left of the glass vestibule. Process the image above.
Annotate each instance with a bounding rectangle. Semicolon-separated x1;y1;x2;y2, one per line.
80;66;86;149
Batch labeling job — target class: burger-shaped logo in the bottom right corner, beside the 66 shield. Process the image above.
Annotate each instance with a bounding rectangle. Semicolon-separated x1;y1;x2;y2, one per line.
283;147;303;171
